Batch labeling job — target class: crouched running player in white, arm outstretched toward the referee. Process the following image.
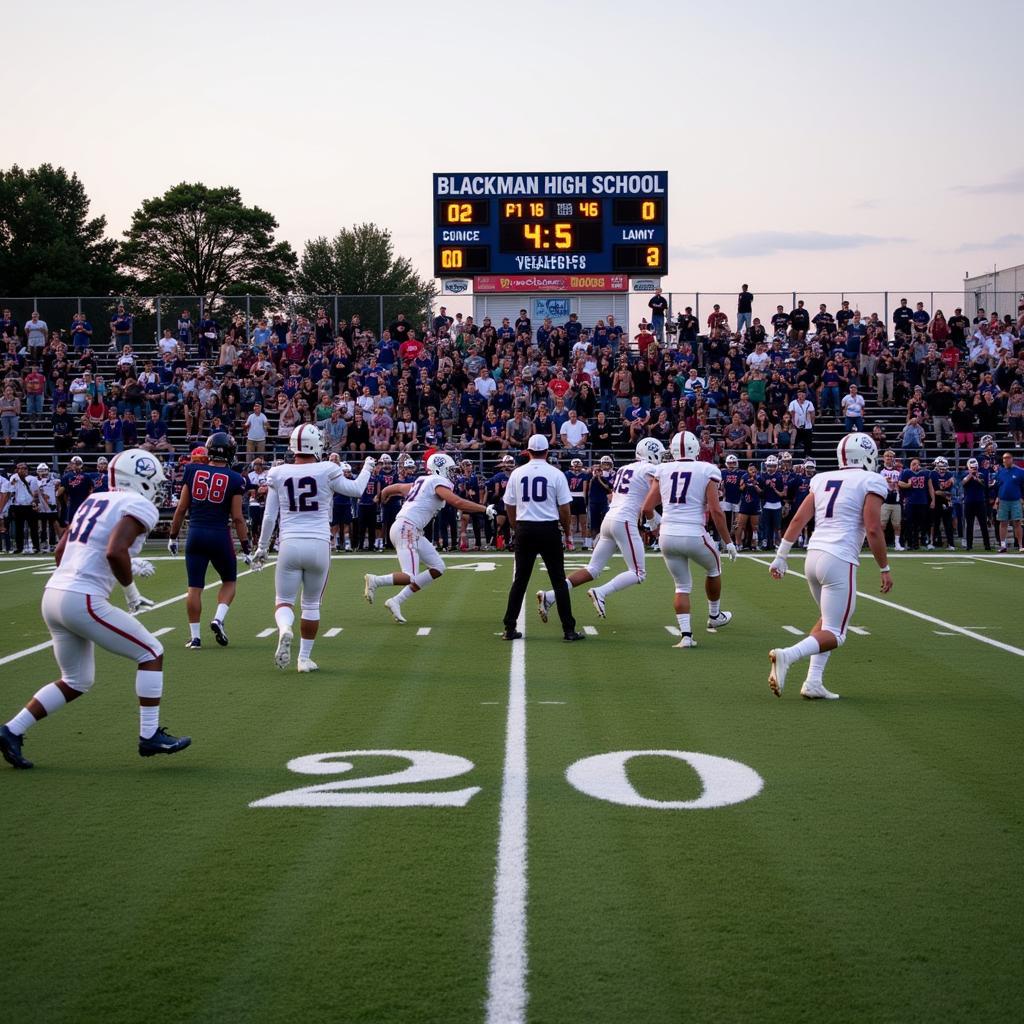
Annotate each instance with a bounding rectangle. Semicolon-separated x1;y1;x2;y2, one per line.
362;452;497;623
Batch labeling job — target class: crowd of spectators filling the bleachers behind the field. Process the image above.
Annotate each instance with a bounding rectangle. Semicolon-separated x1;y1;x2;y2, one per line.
0;285;1024;459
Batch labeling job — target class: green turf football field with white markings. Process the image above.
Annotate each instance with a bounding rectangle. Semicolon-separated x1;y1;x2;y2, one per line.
0;548;1024;1024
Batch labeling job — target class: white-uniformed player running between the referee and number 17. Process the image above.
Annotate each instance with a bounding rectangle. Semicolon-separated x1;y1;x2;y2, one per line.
537;437;668;623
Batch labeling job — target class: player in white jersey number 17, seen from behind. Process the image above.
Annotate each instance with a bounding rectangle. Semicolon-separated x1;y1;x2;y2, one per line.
643;430;736;647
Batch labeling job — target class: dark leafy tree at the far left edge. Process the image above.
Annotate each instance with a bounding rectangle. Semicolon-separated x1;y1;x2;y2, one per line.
0;164;120;296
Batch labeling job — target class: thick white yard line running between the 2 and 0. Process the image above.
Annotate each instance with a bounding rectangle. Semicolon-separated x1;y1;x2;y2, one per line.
486;602;526;1024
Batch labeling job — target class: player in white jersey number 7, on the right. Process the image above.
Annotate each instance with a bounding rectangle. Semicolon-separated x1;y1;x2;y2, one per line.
768;433;893;700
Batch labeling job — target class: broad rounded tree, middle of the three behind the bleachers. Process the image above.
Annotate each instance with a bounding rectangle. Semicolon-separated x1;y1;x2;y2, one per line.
122;182;296;302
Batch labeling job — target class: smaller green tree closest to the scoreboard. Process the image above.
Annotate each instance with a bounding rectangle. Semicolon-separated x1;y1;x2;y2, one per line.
297;224;435;318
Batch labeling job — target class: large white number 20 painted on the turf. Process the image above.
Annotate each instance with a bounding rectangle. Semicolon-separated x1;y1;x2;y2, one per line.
249;751;764;811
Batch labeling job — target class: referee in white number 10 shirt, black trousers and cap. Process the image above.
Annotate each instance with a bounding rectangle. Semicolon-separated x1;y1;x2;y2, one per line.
502;434;586;643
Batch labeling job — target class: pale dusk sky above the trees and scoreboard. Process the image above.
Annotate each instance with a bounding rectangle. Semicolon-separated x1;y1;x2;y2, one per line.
0;0;1024;292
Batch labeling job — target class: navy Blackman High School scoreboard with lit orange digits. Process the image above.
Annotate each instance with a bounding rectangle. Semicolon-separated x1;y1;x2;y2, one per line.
433;171;669;278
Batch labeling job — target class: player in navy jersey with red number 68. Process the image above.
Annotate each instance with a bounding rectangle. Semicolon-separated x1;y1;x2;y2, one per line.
167;430;250;650
